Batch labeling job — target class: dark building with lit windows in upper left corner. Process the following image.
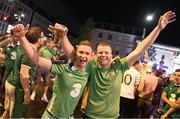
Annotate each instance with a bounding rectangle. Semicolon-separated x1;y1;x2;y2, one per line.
0;0;52;36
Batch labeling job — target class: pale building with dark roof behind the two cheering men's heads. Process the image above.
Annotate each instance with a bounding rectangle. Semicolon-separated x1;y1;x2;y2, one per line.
92;23;141;57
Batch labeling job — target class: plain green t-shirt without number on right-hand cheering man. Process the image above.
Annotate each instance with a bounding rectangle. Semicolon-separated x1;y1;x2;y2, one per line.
85;58;128;118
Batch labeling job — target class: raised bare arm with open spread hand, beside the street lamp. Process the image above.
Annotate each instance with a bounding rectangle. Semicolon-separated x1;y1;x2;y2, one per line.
127;11;176;66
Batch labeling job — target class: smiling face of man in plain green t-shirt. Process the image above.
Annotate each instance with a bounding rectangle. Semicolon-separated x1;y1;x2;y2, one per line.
96;45;112;68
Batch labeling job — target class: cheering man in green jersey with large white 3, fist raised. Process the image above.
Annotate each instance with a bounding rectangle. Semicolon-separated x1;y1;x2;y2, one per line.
11;24;92;118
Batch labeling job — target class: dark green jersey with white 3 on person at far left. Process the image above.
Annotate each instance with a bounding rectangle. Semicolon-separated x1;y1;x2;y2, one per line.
4;44;19;76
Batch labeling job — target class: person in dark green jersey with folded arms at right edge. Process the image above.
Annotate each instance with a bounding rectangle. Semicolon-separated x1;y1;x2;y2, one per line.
160;69;180;119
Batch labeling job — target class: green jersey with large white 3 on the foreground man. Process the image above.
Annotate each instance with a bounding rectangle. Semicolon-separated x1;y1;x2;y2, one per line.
46;64;88;118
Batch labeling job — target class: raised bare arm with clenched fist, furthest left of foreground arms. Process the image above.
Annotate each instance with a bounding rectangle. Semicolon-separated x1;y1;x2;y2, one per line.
13;24;52;70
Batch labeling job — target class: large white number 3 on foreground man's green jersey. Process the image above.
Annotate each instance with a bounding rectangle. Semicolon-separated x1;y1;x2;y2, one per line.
70;83;82;98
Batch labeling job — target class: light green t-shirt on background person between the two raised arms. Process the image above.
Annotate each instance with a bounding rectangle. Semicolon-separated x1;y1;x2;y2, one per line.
39;46;57;59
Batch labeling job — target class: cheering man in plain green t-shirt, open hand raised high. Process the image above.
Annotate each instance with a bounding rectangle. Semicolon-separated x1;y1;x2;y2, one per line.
50;11;176;118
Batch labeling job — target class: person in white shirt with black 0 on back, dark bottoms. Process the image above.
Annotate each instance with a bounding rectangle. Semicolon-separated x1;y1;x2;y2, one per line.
120;60;141;118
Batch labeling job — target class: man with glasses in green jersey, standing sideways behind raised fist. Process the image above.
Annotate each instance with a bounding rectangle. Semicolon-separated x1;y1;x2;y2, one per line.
2;27;44;118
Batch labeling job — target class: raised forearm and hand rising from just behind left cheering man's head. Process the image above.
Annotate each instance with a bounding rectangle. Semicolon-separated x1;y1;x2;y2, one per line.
48;23;75;59
